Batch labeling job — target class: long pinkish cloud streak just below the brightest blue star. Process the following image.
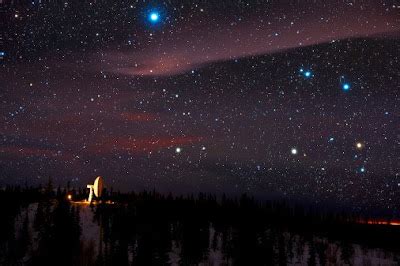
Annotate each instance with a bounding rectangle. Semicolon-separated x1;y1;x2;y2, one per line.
101;5;400;76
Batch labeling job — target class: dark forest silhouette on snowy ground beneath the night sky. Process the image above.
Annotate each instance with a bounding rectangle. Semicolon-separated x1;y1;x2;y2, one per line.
0;181;400;265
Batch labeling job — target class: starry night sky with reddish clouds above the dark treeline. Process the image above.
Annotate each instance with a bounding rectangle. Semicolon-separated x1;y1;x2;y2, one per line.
0;0;400;211
